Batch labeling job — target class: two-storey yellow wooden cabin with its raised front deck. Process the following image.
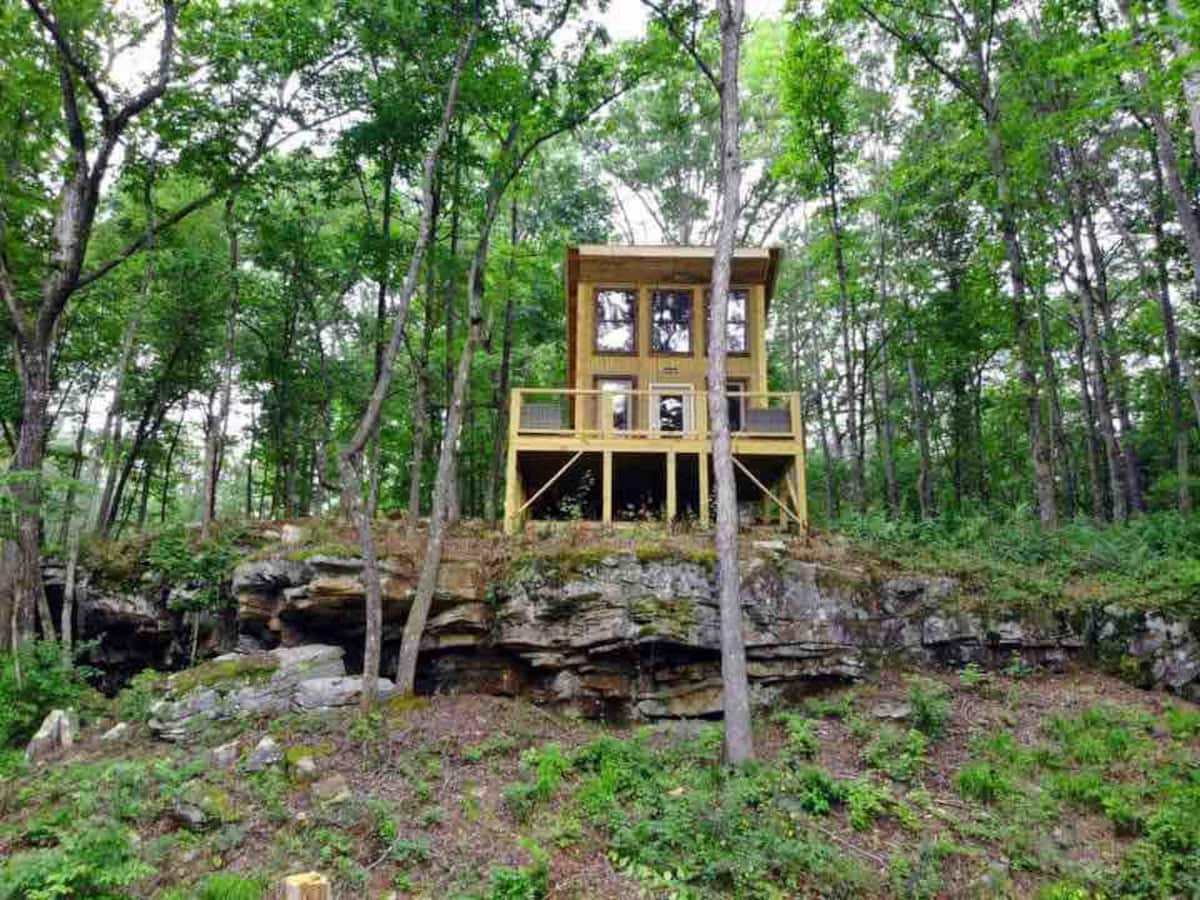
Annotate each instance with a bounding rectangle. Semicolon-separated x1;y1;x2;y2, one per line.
504;245;808;533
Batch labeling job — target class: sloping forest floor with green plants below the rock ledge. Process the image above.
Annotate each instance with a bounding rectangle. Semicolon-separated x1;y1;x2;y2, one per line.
0;667;1200;900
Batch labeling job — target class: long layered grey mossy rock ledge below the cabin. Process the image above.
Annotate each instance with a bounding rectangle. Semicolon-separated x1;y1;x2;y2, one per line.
49;545;1200;719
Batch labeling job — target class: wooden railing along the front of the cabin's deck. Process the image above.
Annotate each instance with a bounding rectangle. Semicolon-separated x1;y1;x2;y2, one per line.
511;386;803;442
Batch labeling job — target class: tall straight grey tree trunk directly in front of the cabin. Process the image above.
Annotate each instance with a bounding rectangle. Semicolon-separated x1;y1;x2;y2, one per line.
701;0;748;764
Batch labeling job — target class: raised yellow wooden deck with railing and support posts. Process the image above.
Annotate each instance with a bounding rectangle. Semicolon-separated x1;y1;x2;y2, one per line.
504;388;808;533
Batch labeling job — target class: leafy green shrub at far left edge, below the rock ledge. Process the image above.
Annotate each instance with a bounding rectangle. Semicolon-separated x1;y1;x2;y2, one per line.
0;641;95;746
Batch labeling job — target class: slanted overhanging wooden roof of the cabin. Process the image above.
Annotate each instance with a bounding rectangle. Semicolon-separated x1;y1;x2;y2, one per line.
563;244;784;386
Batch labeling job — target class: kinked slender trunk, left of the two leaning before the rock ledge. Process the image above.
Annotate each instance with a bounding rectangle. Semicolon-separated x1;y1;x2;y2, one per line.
338;31;479;709
